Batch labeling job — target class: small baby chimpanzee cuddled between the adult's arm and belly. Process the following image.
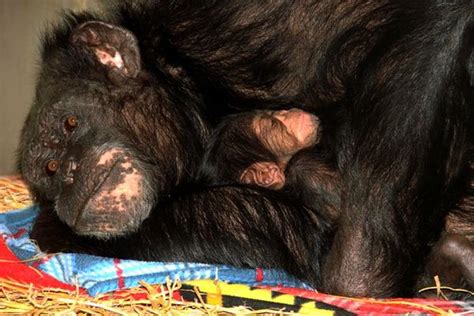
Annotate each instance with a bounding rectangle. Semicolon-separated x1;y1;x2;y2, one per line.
200;109;340;220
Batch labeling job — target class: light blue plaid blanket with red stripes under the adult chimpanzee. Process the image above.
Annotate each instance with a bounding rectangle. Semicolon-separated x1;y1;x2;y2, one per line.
0;206;310;295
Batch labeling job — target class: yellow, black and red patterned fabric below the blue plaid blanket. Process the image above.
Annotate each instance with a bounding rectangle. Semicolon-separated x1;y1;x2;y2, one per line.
185;280;474;315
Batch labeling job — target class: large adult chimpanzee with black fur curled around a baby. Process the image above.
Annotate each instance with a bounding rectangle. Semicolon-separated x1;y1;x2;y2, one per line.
16;0;474;296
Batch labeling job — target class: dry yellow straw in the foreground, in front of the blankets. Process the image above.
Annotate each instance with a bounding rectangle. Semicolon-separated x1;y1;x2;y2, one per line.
0;279;289;315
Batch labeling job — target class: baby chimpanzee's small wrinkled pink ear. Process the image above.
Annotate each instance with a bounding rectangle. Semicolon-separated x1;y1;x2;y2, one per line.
240;162;285;190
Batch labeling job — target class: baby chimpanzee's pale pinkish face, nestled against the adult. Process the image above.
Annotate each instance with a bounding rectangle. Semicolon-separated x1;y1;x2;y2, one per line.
253;109;320;160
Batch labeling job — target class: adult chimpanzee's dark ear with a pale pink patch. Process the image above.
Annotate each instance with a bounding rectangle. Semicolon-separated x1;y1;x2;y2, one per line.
70;21;141;78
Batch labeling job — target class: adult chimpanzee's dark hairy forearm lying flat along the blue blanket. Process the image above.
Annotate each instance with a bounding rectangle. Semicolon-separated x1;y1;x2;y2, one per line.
31;187;329;287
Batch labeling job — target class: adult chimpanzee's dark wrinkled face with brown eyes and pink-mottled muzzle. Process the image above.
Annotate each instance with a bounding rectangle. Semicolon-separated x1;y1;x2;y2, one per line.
21;87;154;236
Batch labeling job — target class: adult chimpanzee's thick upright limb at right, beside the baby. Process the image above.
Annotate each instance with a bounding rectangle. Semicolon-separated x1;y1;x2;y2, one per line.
323;6;474;296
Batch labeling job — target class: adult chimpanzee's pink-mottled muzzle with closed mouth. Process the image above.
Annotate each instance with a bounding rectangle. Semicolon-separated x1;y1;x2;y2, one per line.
62;154;149;238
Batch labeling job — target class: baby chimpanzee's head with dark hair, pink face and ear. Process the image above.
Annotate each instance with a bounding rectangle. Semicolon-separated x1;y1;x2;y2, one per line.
200;109;320;189
